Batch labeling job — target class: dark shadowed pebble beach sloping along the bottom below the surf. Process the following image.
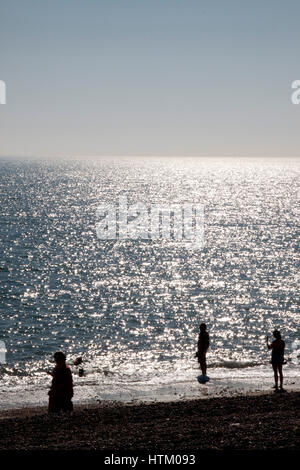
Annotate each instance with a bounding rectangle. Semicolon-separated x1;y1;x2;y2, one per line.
0;392;300;452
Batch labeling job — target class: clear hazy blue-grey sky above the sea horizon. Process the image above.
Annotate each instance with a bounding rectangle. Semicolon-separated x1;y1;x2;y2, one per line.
0;0;300;156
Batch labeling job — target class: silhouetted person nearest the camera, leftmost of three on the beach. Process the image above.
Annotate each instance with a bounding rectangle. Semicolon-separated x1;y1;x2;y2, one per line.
48;351;73;413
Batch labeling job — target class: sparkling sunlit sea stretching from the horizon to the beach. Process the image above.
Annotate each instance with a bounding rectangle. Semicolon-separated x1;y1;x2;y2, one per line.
0;158;300;407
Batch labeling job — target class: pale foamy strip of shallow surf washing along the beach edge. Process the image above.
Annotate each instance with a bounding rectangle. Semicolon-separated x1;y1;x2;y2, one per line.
0;367;300;413
